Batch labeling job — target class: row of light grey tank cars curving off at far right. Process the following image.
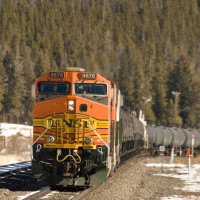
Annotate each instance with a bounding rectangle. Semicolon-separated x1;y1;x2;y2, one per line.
146;125;200;155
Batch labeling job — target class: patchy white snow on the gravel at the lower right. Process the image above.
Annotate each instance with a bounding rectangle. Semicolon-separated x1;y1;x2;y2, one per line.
145;159;200;200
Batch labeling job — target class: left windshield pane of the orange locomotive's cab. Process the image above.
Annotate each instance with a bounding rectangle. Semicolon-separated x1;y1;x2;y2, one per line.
38;82;71;95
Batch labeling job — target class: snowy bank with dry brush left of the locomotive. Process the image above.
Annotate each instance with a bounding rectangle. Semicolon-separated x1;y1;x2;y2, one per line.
0;123;33;166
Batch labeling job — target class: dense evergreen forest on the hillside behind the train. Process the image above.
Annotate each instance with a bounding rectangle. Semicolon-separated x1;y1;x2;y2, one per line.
0;0;200;128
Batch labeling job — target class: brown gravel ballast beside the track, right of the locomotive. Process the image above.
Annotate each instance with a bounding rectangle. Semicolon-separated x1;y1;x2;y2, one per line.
83;156;200;200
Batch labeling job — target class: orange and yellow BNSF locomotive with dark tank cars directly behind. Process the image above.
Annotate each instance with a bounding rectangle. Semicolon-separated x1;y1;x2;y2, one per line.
32;68;144;185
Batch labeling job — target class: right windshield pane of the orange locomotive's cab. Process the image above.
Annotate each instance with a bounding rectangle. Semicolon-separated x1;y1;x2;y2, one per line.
75;83;107;95
